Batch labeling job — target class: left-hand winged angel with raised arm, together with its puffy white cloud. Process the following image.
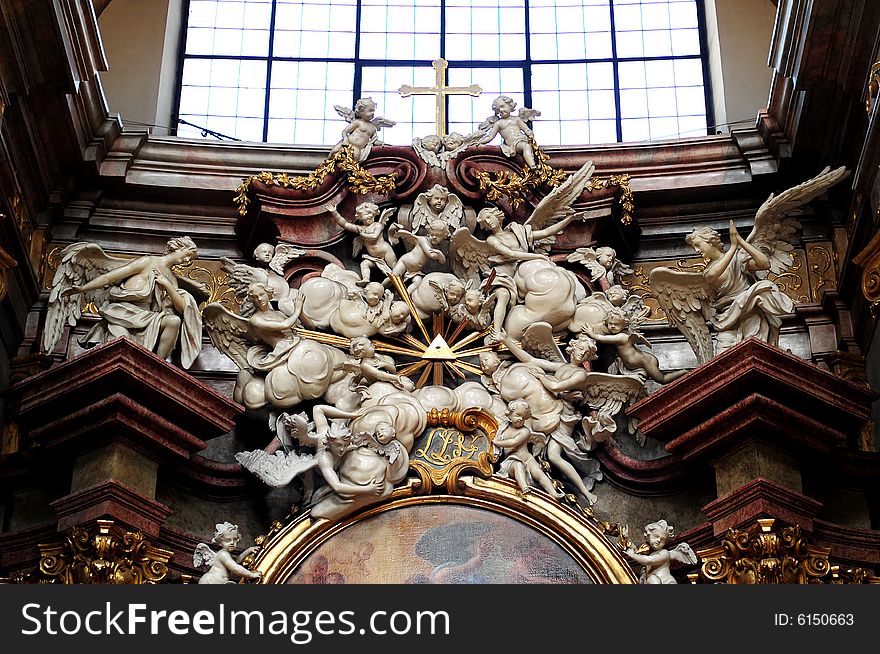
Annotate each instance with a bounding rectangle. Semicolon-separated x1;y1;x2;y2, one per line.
204;282;350;410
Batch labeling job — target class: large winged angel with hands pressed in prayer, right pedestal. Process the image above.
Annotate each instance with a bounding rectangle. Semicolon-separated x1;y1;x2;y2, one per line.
649;167;849;363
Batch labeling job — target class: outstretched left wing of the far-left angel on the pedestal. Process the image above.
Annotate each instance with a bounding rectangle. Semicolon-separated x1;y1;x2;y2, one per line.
43;243;131;352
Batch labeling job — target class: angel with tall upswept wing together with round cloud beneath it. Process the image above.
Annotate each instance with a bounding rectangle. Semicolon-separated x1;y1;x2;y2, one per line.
449;162;595;341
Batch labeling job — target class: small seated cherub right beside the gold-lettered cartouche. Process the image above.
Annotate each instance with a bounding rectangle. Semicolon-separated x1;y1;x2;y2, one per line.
492;400;565;498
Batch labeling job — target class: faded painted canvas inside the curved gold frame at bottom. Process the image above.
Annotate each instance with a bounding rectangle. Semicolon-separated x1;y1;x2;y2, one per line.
288;504;591;584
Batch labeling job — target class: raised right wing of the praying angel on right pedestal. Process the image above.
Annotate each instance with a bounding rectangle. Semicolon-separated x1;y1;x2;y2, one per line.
746;166;849;274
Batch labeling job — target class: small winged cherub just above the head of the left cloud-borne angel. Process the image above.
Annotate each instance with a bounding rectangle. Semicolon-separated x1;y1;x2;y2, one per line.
220;243;305;318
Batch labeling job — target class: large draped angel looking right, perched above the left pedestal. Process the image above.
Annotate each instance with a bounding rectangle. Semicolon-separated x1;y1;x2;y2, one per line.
43;236;207;368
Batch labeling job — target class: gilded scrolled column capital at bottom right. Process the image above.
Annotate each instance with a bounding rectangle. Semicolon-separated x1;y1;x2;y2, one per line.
696;518;877;584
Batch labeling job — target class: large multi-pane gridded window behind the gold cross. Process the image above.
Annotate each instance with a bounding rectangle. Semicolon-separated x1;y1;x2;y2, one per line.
177;0;711;145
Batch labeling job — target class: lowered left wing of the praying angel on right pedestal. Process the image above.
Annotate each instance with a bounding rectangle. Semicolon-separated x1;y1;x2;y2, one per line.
648;267;715;363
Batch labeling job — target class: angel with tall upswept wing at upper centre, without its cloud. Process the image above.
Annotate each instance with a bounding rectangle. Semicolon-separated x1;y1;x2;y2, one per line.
449;162;595;339
